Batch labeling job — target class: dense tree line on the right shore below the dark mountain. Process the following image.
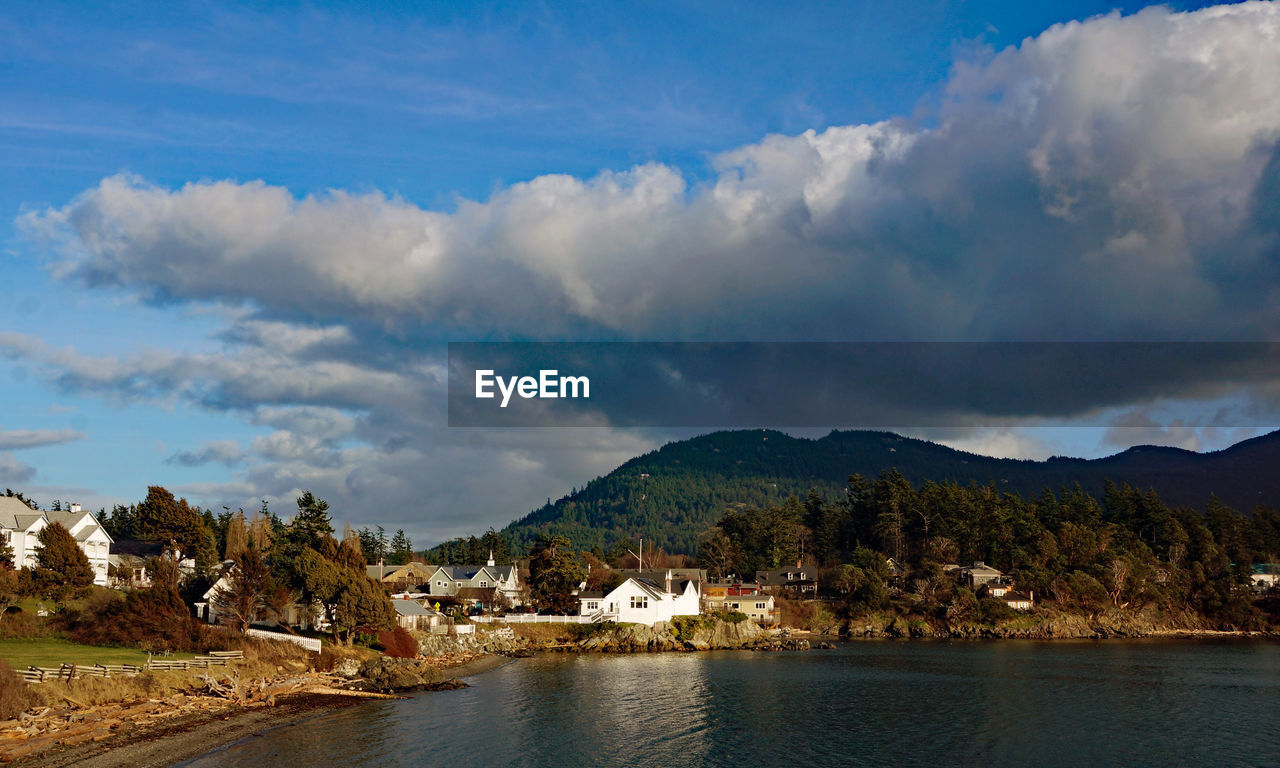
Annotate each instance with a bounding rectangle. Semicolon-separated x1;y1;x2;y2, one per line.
698;470;1280;626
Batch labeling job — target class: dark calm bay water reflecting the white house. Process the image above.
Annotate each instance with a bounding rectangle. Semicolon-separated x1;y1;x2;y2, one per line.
189;641;1280;768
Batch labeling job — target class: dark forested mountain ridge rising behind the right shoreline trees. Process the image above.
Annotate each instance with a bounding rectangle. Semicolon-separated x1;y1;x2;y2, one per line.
491;430;1280;553
